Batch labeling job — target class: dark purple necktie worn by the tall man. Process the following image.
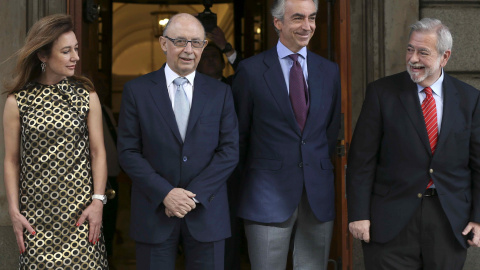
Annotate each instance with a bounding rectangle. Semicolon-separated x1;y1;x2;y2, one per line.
289;54;310;132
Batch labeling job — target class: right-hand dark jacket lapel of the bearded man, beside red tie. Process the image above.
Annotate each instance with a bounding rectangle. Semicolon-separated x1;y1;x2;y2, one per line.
437;74;460;151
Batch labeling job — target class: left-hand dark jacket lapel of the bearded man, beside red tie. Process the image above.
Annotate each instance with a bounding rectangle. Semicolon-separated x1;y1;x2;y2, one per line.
398;72;432;155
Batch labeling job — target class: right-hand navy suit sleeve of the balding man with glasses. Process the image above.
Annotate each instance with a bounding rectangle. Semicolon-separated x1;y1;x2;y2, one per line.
186;85;238;208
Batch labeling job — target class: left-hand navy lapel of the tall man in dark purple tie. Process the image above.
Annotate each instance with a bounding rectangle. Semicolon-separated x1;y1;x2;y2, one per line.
263;46;301;136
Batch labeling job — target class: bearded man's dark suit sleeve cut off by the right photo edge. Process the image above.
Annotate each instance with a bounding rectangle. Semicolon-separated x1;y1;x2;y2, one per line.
469;92;480;223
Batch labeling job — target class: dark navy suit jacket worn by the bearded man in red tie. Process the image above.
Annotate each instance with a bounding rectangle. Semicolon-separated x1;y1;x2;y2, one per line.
347;72;480;247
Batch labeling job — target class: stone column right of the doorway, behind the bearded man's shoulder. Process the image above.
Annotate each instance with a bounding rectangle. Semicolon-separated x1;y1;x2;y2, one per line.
350;0;419;131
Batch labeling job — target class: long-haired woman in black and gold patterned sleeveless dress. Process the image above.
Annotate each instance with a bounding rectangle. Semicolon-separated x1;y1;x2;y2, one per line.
3;14;108;269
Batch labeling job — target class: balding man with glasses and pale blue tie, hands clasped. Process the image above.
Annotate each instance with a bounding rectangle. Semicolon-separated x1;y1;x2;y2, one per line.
118;14;238;270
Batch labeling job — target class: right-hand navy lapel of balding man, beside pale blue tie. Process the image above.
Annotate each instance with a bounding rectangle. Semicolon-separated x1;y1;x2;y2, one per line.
185;75;208;140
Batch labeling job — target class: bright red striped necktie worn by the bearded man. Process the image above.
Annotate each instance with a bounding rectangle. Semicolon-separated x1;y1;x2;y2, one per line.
422;87;438;188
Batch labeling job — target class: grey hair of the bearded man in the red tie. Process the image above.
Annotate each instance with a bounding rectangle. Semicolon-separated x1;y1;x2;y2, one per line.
409;18;453;55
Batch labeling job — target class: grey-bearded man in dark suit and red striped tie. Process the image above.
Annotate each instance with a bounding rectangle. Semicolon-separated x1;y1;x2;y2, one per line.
347;18;480;270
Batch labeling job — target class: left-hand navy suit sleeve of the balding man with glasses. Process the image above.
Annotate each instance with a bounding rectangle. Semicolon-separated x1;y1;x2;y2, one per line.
117;83;173;205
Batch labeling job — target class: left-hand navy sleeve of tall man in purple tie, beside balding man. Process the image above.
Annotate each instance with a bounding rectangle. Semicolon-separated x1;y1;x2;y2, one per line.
233;62;253;172
